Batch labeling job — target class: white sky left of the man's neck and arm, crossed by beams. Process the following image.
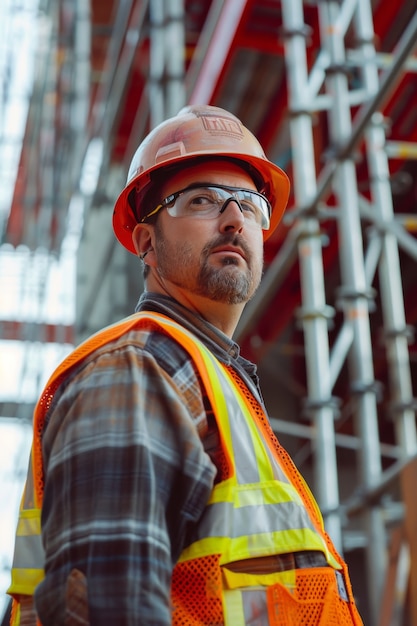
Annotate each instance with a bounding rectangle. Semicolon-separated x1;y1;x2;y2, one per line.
0;234;76;619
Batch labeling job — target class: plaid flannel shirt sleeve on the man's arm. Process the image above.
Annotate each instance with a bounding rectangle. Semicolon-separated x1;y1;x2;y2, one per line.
35;334;216;626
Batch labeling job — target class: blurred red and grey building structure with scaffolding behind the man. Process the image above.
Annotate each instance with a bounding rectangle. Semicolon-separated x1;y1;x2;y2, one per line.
2;0;417;626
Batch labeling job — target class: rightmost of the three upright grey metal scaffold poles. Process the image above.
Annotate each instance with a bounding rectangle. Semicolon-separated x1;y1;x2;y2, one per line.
355;0;417;458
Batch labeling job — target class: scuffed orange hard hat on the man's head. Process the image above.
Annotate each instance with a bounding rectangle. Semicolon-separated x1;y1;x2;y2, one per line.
113;104;290;254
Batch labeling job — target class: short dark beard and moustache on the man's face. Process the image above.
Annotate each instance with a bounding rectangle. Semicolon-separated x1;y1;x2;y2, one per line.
155;225;262;304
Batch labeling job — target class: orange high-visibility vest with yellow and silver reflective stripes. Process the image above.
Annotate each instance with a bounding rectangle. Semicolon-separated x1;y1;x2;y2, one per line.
8;312;362;626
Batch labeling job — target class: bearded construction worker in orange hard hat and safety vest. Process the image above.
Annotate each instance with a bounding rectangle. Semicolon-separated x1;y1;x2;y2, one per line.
9;105;362;626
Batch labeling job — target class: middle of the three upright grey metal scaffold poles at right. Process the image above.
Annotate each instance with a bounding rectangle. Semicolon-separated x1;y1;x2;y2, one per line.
318;0;385;623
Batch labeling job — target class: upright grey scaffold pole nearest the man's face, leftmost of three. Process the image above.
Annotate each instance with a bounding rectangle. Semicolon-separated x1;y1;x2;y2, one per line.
282;0;342;551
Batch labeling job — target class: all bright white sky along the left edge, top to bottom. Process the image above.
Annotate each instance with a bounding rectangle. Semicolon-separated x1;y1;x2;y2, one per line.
0;0;83;620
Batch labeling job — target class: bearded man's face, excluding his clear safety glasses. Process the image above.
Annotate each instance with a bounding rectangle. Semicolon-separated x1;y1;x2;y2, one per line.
150;161;263;304
